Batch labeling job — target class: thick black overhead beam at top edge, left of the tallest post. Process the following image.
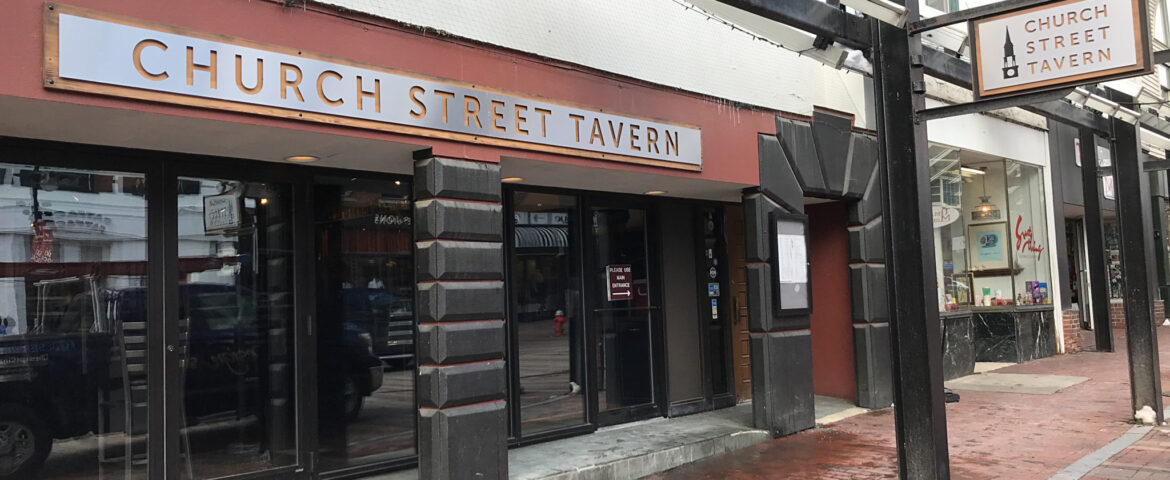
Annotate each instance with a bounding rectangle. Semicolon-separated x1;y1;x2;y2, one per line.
718;0;873;50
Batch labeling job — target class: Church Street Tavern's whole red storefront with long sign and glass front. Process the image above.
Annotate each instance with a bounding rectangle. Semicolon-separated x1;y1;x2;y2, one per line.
0;1;790;479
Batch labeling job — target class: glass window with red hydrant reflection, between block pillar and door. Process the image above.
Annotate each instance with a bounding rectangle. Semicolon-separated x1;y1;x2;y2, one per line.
510;192;585;436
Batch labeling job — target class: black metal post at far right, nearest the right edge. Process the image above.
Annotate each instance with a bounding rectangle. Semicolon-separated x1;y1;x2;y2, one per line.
1110;91;1163;424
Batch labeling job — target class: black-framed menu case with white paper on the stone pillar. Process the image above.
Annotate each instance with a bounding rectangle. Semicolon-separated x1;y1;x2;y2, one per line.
769;212;812;317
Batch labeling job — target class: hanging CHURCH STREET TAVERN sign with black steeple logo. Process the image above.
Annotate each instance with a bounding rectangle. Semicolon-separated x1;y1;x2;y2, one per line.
969;0;1152;98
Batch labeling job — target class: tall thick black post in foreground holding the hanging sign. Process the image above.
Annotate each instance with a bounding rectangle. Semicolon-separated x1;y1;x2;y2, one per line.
874;5;950;479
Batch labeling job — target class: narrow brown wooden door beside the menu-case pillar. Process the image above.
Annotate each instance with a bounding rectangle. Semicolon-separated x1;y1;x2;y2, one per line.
724;205;751;402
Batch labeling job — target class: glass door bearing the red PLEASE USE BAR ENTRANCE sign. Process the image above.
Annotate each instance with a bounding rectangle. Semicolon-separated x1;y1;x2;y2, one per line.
586;205;656;425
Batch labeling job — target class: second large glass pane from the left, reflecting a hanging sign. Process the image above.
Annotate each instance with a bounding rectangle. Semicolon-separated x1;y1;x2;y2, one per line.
177;178;297;478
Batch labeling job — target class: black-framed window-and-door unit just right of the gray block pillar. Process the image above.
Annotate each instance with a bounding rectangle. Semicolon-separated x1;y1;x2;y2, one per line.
505;188;662;443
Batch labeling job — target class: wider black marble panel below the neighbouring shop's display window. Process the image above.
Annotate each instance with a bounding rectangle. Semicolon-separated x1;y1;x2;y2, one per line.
971;306;1057;363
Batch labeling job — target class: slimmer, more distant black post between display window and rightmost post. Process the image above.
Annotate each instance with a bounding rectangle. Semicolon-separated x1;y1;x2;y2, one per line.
1080;129;1113;351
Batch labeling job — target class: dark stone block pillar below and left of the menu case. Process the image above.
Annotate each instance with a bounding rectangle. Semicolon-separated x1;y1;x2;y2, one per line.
743;192;817;437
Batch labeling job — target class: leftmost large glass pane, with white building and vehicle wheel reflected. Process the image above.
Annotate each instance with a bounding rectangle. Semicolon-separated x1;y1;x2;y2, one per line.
0;164;153;479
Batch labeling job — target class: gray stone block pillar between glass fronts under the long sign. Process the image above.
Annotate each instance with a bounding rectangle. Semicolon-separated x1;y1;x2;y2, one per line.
414;150;508;480
